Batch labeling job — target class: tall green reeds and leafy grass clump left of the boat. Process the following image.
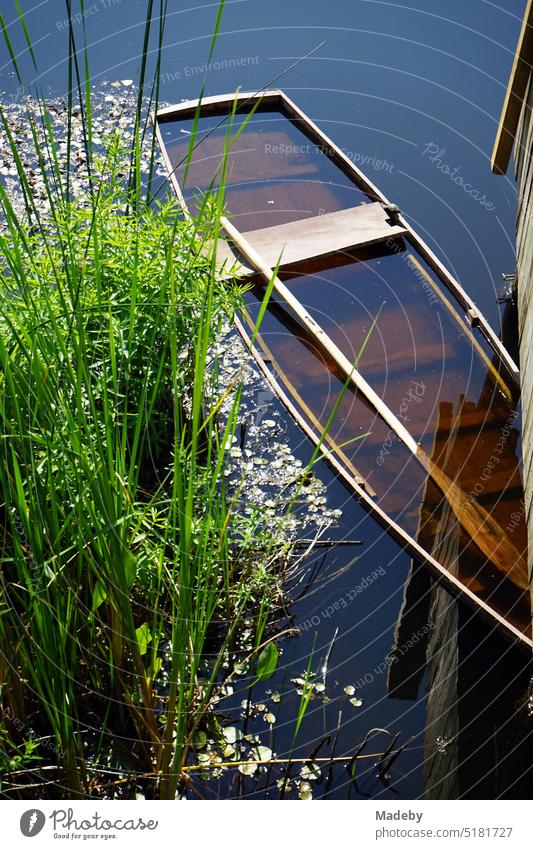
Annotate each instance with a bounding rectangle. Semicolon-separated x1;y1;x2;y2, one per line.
0;3;296;799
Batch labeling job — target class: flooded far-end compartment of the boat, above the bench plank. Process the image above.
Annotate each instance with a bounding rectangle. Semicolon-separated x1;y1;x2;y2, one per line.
160;109;368;232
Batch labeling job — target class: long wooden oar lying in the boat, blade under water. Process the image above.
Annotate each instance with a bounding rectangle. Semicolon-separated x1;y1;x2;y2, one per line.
220;216;528;589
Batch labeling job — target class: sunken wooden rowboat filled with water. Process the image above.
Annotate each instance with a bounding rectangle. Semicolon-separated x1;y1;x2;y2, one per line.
156;91;532;649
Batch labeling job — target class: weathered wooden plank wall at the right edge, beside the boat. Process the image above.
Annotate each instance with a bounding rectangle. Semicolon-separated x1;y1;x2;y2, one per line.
514;74;533;595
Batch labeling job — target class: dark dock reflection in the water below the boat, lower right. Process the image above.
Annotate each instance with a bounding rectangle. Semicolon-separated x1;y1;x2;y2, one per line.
388;563;531;799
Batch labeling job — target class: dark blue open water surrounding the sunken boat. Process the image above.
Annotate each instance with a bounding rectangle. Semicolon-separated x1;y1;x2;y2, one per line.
0;0;528;798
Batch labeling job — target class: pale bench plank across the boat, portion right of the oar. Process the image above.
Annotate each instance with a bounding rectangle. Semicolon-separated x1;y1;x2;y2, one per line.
241;203;407;267
